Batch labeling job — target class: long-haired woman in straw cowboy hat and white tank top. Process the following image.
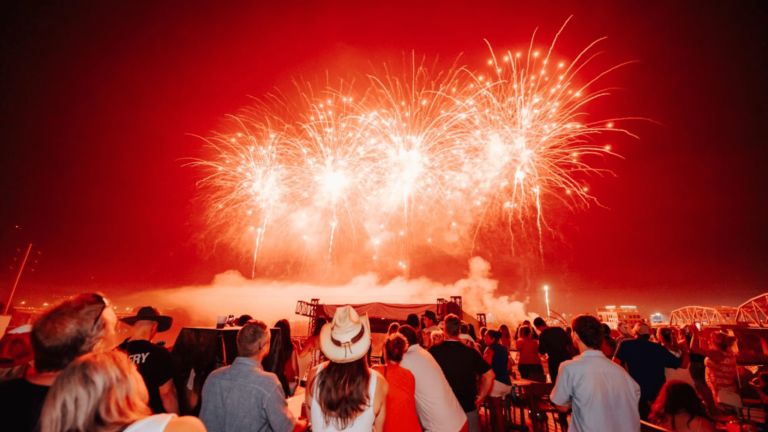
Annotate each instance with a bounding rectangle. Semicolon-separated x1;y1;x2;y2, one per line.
306;306;388;432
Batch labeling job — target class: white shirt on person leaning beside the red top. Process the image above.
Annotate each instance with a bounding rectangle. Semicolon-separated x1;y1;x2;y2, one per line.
400;345;467;432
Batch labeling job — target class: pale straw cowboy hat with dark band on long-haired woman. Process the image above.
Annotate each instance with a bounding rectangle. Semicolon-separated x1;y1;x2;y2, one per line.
320;306;371;363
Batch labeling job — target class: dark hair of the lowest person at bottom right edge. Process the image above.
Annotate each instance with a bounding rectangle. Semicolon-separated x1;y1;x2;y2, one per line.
649;380;712;430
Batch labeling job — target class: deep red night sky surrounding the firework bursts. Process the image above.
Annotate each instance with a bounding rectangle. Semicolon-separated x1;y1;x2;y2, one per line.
0;0;768;313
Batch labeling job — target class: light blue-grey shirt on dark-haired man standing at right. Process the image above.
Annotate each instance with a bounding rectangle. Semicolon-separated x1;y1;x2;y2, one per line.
550;350;640;432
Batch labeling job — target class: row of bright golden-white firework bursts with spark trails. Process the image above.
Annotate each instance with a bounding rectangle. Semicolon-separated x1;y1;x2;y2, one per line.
193;30;625;277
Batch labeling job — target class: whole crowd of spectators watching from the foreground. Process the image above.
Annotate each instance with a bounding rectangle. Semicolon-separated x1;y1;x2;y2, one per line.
0;294;756;432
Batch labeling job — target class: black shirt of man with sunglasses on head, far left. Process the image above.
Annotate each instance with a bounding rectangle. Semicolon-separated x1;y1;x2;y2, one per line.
0;378;50;432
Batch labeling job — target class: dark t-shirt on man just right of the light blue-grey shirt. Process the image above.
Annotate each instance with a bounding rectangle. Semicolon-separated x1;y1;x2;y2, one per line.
616;339;681;401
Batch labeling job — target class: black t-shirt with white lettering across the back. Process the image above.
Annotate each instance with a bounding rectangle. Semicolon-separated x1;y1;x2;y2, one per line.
120;340;173;414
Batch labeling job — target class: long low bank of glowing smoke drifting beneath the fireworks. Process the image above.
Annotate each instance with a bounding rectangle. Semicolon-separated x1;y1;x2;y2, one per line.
121;257;538;339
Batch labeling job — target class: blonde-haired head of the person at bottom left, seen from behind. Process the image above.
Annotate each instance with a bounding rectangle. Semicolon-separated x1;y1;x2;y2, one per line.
40;351;152;432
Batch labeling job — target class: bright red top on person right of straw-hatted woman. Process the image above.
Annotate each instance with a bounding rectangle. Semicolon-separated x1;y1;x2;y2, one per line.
379;365;422;432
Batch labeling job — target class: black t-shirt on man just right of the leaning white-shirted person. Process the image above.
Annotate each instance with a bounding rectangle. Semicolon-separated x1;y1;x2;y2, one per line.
429;340;491;412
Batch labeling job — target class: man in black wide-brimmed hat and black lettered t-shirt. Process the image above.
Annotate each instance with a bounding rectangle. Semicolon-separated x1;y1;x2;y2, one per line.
120;306;179;414
